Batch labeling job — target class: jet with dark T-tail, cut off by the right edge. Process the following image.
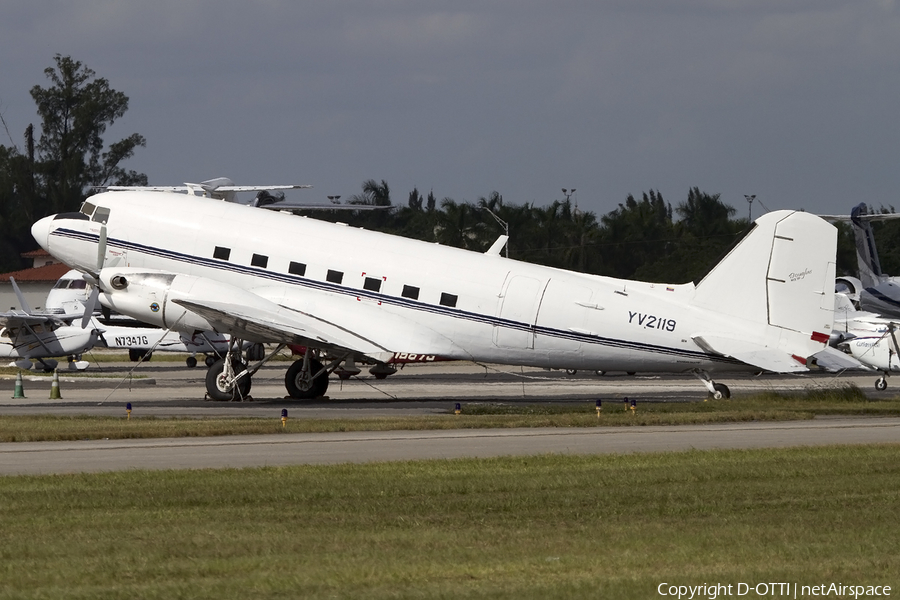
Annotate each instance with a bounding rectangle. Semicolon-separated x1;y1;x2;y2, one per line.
823;203;900;319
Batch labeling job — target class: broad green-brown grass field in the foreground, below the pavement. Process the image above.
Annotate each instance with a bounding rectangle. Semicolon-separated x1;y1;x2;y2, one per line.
0;446;900;599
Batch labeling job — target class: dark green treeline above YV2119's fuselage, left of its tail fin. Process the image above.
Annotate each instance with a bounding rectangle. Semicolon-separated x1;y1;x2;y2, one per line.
328;180;788;283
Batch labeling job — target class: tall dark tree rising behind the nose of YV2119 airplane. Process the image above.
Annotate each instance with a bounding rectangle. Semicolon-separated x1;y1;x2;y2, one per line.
31;54;147;219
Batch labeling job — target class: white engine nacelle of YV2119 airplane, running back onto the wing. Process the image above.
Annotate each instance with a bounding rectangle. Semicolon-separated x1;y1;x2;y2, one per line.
100;267;272;332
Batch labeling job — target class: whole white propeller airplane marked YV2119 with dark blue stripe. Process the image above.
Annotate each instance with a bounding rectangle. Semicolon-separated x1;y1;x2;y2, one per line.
32;191;837;400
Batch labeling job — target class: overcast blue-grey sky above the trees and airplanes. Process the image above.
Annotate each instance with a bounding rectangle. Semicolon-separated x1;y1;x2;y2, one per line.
0;0;900;216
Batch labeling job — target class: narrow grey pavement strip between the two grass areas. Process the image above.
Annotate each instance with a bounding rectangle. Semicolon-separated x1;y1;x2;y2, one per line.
0;417;900;475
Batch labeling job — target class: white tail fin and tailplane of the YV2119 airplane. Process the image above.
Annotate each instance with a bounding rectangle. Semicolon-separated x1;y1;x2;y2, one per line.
692;211;837;371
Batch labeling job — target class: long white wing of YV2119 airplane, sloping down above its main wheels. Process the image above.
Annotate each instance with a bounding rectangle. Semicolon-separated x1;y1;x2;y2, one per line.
173;300;394;360
